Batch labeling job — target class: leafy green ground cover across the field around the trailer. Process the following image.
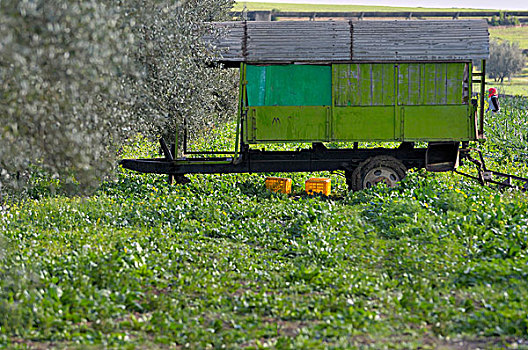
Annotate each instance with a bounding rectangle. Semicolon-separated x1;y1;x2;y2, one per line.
0;98;528;349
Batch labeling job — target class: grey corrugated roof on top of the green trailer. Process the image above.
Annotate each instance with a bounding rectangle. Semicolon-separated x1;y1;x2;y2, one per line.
208;20;489;63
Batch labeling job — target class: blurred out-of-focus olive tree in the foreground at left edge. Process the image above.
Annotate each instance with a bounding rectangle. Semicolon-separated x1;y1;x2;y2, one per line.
0;0;136;197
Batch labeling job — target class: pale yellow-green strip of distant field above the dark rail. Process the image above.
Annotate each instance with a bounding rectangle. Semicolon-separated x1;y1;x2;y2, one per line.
233;1;488;12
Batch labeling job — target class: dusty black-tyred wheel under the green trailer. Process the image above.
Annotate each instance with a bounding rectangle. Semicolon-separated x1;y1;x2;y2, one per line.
347;156;407;191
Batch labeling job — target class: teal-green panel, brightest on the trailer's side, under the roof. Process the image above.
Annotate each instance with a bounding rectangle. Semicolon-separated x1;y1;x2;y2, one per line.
246;65;332;106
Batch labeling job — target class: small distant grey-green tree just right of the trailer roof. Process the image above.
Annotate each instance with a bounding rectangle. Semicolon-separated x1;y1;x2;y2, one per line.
486;39;525;83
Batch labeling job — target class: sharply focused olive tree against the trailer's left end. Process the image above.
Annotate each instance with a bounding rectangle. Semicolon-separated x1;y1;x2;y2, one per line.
123;0;237;153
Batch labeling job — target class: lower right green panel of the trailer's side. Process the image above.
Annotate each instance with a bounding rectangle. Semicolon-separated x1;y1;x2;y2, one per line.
401;105;472;141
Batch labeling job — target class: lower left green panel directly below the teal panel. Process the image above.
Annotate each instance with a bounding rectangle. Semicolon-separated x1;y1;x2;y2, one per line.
246;106;331;143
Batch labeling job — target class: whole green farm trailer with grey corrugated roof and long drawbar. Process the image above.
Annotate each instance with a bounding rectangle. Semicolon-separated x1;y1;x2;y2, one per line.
121;20;528;190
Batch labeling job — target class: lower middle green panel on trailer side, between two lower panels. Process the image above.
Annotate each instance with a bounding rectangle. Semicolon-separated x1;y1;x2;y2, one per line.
333;106;394;141
